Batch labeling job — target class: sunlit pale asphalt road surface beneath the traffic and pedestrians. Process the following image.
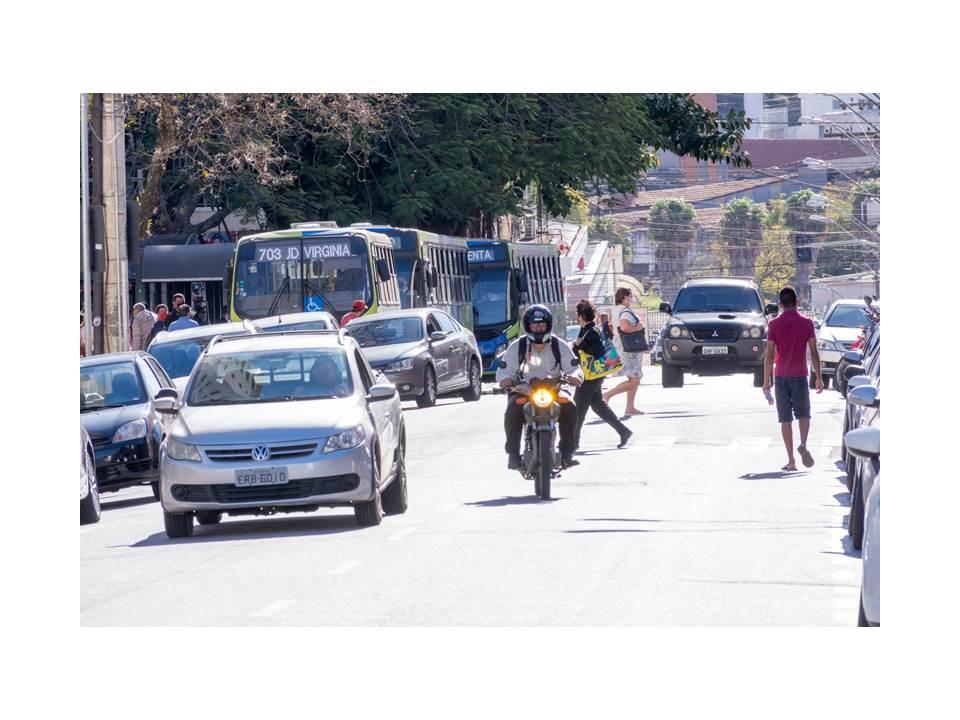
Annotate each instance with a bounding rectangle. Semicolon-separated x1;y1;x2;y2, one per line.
80;368;860;627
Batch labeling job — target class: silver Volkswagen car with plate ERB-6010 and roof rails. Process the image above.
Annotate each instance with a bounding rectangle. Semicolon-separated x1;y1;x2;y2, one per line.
154;331;407;538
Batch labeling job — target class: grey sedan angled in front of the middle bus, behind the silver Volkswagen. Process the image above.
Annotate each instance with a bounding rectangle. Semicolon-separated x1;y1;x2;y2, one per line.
346;308;481;407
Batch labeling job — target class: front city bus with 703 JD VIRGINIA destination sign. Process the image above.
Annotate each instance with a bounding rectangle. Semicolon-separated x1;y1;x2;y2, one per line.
224;222;400;322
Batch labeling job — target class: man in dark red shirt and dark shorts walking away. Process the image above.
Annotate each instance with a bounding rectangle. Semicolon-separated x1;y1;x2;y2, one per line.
763;285;823;470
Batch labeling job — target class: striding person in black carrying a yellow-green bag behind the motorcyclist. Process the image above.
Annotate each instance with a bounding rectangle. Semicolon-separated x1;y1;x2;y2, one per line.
573;300;633;448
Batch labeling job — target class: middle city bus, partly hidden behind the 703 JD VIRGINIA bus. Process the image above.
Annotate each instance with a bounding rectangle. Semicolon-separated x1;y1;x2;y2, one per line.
350;223;473;330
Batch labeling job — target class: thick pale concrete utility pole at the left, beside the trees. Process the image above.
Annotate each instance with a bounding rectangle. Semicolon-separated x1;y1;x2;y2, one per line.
101;93;130;352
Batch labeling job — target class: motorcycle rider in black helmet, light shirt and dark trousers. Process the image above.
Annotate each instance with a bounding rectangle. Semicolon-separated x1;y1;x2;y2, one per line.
497;305;583;470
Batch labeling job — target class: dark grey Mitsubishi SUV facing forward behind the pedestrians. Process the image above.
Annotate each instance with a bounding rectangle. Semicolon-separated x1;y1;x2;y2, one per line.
660;277;777;388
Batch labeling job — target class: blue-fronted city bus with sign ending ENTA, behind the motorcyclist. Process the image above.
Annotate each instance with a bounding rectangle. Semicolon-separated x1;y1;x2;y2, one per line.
467;240;566;380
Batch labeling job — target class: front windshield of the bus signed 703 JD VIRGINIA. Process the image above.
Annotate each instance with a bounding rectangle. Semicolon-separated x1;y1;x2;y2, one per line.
233;237;373;318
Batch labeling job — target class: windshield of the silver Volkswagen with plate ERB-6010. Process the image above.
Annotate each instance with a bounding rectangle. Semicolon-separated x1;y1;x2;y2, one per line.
187;348;353;407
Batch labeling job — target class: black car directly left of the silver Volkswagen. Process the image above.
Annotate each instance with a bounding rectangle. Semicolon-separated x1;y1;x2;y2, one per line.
80;350;174;497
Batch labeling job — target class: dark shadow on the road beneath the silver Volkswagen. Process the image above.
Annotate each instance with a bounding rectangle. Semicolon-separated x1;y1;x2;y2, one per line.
119;515;364;548
